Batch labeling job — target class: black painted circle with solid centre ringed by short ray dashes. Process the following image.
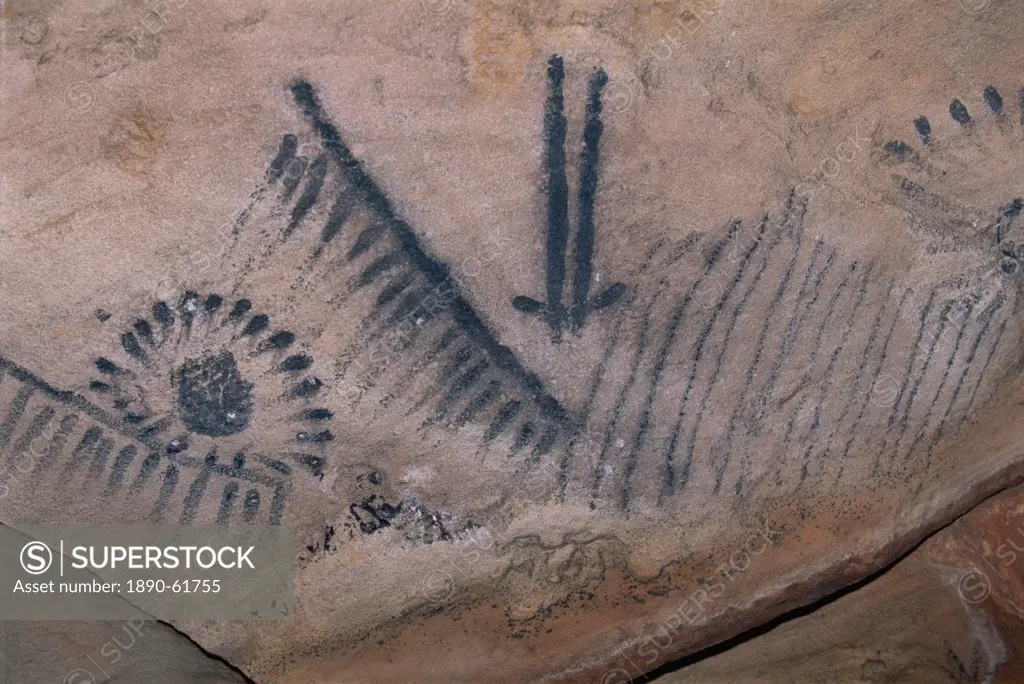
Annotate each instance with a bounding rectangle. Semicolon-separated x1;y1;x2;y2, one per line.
89;292;334;477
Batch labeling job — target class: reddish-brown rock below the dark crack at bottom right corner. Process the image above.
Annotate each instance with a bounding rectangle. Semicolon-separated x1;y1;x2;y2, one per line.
651;487;1024;684
